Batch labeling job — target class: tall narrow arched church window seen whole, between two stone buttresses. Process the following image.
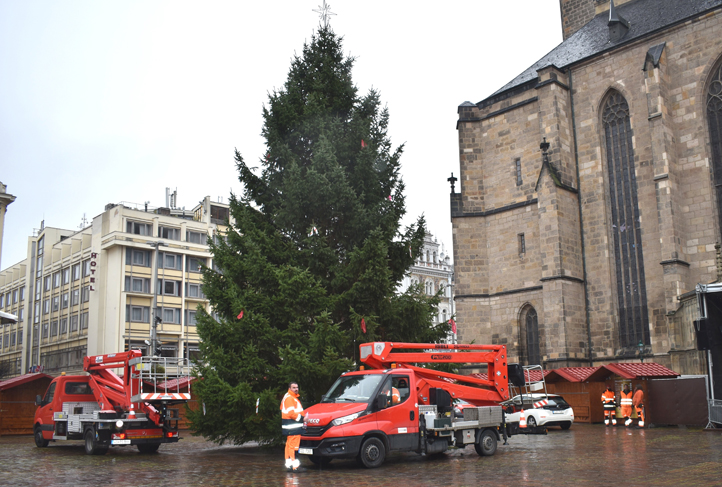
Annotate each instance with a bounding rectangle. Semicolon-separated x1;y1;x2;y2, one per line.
602;91;649;349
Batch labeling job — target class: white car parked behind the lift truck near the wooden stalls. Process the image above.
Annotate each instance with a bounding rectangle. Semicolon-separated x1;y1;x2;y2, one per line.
501;394;574;430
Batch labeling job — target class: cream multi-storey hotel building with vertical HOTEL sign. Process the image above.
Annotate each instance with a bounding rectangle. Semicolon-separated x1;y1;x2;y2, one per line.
0;197;229;378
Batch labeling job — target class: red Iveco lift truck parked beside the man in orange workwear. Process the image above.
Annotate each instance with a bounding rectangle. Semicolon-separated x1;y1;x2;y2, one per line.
299;342;510;468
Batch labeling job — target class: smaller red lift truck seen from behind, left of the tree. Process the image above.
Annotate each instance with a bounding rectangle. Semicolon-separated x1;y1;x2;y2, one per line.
34;350;190;455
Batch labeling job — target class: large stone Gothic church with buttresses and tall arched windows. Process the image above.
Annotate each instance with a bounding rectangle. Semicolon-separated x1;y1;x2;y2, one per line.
450;0;722;374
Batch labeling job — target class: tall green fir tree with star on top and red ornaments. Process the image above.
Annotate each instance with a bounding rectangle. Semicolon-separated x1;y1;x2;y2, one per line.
189;27;449;444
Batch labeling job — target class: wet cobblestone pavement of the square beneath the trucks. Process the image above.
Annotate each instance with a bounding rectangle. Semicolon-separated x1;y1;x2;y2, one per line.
0;424;722;487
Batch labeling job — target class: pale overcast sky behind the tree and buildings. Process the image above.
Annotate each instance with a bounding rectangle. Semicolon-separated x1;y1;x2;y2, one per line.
0;0;562;268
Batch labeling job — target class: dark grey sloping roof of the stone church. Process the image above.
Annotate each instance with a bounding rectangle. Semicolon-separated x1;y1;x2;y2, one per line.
478;0;722;108
